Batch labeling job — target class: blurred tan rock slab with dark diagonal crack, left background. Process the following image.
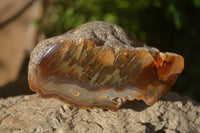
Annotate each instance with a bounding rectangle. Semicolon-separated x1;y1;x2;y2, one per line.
0;0;42;89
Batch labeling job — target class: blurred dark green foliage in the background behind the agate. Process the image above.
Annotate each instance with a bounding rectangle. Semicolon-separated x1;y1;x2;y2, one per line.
38;0;200;101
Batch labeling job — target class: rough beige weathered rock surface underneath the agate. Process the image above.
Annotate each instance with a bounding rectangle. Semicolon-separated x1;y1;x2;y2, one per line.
0;92;200;133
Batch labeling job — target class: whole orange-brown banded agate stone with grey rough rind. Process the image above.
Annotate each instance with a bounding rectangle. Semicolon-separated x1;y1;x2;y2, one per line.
28;21;184;111
